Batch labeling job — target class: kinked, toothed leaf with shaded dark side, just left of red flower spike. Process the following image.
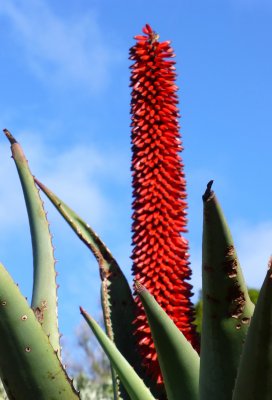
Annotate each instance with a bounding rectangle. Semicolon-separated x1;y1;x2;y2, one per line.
35;178;144;399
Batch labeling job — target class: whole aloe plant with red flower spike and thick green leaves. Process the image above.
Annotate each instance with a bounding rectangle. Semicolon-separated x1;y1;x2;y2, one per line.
0;25;272;400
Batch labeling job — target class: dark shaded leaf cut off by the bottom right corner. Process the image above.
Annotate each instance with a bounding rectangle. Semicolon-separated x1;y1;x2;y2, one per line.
233;260;272;400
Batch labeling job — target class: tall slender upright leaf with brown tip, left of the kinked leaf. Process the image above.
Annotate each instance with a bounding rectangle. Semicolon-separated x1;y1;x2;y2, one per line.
4;129;60;356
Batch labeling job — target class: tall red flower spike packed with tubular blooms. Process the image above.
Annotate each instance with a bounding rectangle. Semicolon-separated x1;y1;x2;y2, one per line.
130;25;198;384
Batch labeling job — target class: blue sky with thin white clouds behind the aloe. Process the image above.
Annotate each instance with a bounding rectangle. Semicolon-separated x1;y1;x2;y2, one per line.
0;0;272;362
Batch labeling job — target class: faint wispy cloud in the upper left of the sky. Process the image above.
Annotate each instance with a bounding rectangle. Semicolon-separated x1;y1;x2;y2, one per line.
0;0;119;92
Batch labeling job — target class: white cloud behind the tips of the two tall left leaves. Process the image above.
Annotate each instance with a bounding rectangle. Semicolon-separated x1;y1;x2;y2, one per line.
0;133;126;233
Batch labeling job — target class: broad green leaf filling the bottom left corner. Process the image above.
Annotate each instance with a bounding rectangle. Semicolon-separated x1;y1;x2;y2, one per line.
0;264;79;400
